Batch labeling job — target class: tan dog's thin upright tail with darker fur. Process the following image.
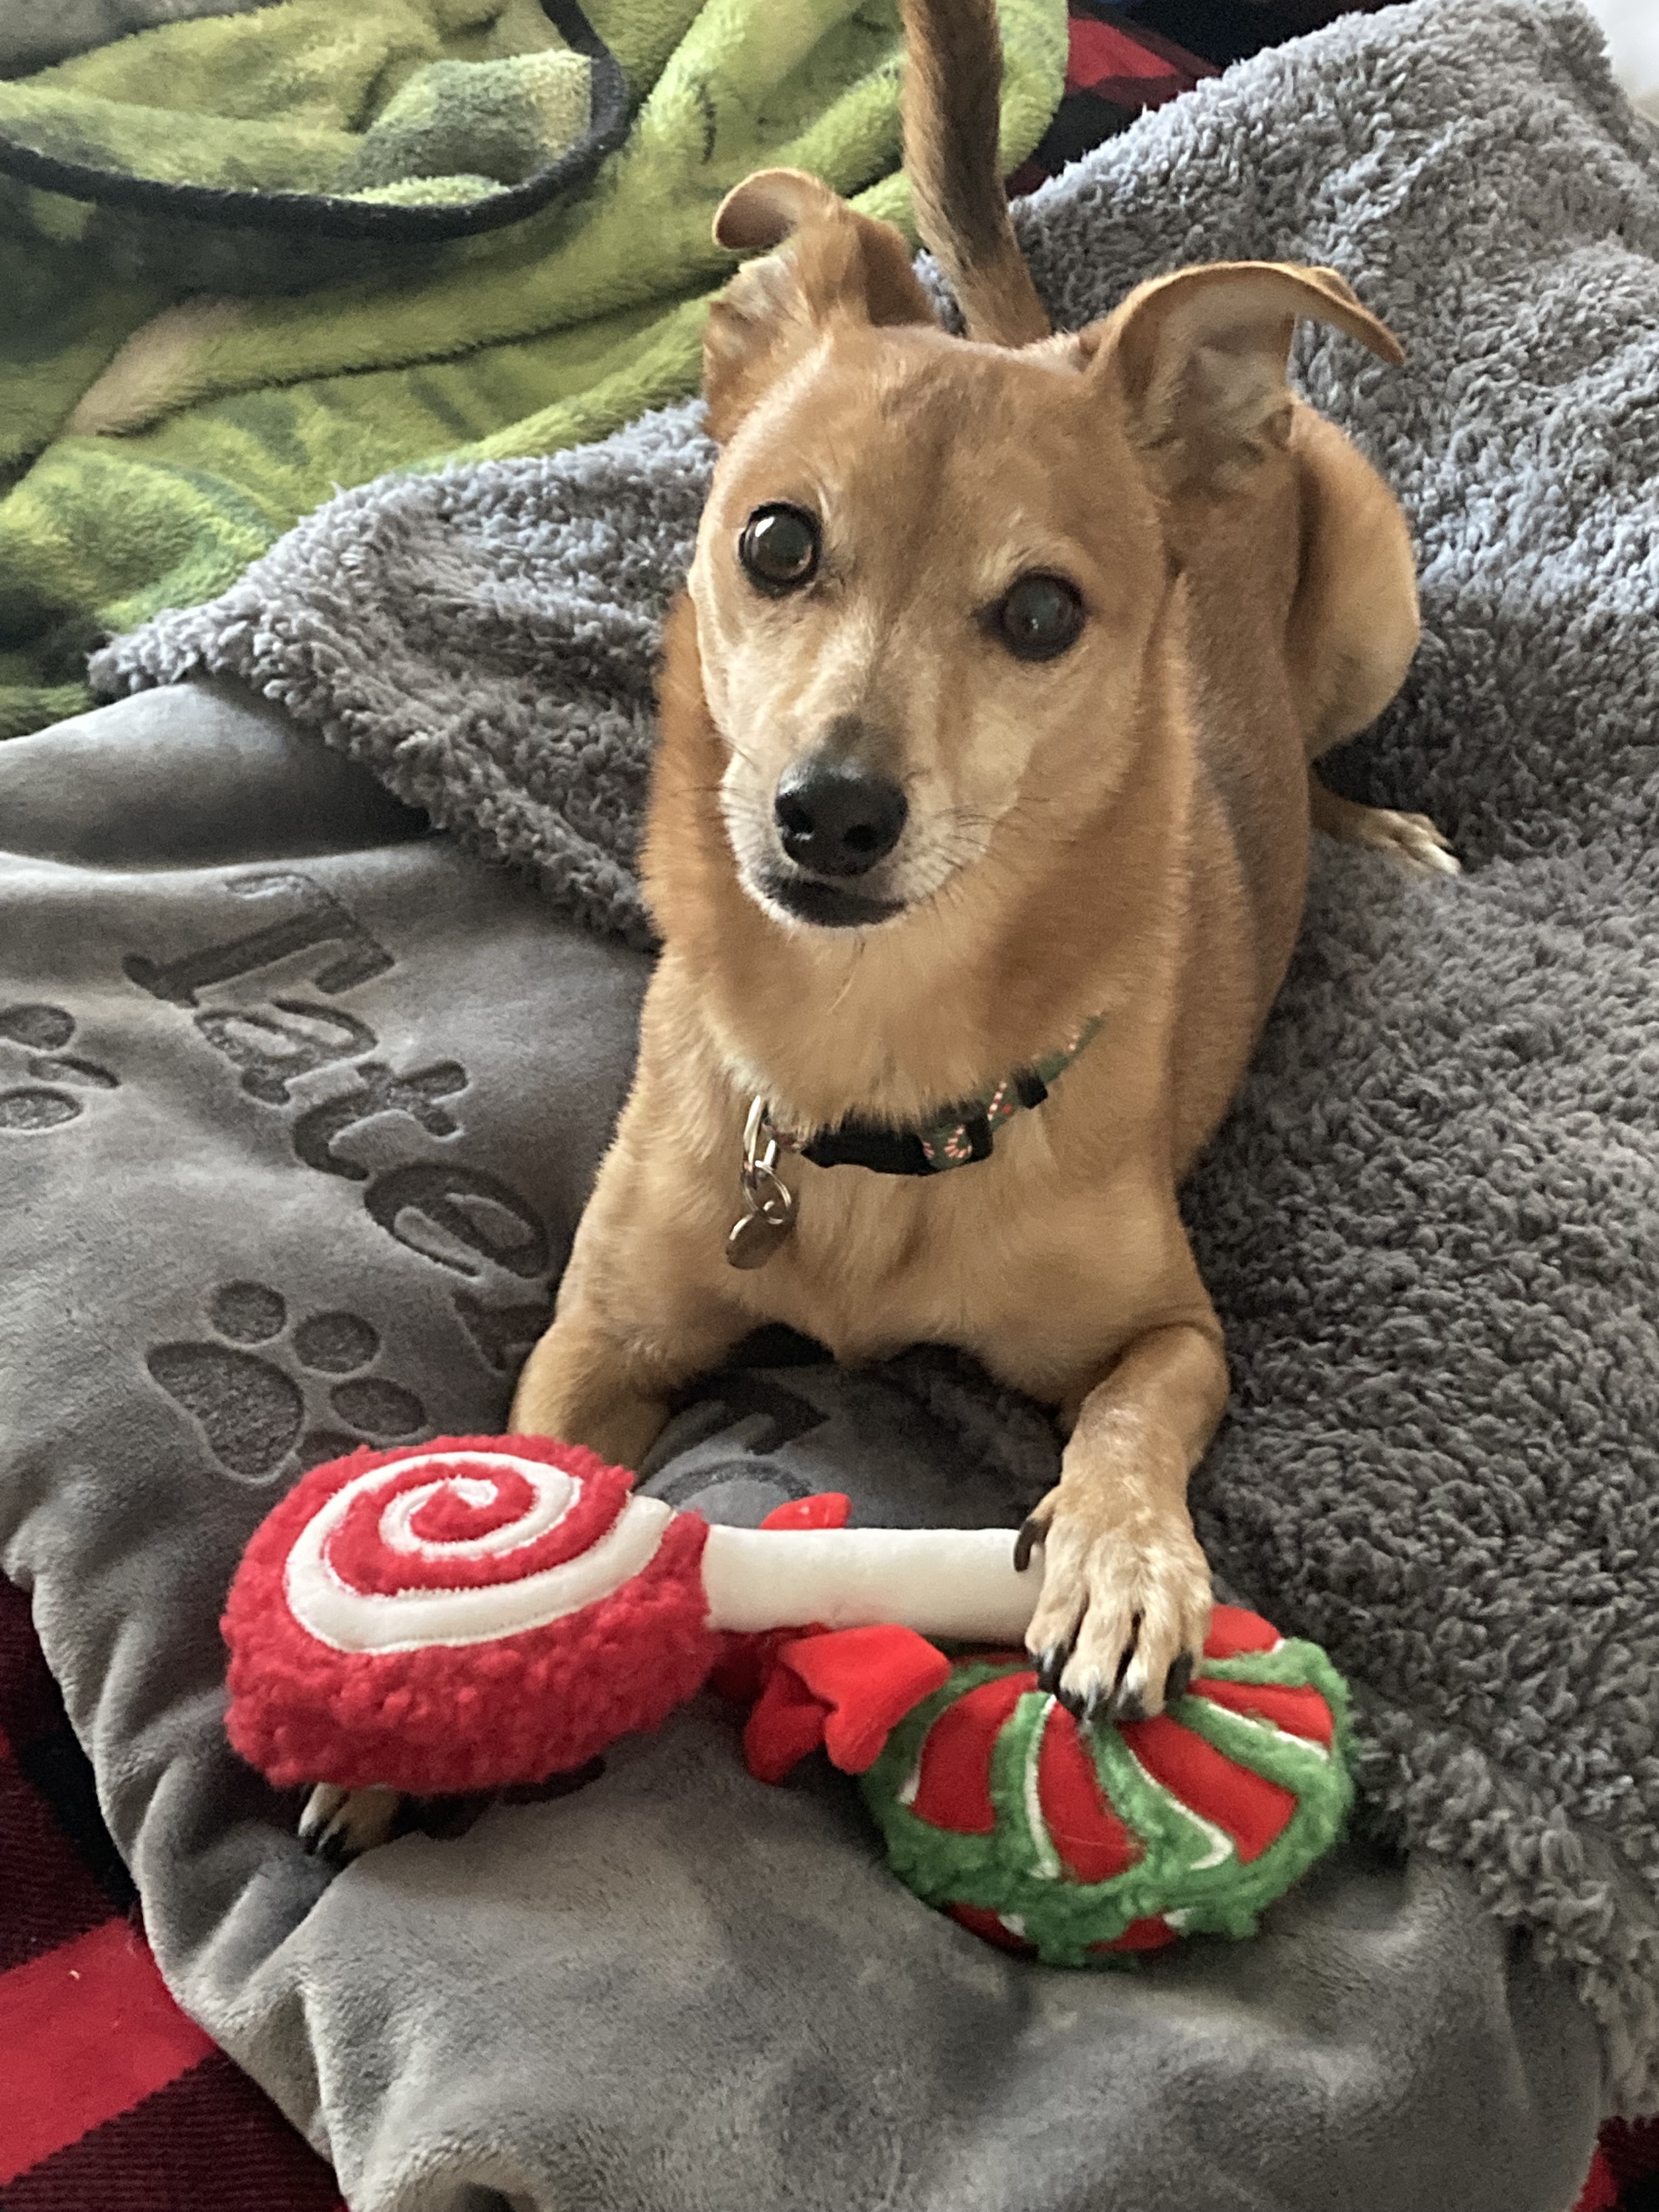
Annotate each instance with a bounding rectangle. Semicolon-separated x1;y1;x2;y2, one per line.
902;0;1048;345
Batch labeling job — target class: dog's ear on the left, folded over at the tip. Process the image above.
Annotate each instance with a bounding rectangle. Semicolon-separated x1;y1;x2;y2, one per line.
703;168;936;440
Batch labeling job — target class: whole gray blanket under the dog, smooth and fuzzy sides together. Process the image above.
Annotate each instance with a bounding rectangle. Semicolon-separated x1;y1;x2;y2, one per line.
0;0;1659;2212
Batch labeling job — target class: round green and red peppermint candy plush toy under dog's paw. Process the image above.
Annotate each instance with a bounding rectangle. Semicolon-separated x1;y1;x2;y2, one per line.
743;1606;1352;1966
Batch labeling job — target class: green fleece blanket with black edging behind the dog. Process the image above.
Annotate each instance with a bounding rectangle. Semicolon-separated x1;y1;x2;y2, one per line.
0;0;1066;735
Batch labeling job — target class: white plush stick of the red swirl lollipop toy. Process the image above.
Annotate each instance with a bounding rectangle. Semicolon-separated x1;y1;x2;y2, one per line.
703;1526;1042;1644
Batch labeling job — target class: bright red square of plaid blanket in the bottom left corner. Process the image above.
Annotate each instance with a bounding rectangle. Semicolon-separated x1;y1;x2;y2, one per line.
0;1920;212;2188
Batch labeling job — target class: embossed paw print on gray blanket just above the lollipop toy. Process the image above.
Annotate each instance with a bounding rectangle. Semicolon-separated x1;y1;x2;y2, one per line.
144;1283;429;1482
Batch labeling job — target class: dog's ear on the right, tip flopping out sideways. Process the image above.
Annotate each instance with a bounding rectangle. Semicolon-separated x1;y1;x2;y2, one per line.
1082;261;1404;495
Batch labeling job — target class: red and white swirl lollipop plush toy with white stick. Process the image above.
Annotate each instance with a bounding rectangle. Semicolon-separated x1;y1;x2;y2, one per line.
223;1436;1040;1796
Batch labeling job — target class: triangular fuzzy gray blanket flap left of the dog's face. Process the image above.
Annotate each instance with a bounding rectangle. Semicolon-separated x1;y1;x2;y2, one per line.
91;405;714;947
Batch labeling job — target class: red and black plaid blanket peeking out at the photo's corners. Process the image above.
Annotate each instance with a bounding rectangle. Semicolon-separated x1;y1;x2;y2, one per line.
0;0;1659;2212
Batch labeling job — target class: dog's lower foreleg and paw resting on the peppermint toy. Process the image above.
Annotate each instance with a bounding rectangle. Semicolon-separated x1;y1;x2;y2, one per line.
1015;1307;1228;1719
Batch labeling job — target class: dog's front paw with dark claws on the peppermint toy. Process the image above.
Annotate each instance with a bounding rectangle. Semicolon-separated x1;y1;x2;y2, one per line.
1020;1482;1212;1723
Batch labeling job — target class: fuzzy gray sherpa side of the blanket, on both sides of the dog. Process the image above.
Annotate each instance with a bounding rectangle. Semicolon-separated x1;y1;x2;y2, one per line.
95;0;1659;2108
